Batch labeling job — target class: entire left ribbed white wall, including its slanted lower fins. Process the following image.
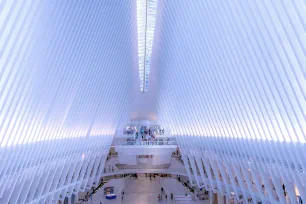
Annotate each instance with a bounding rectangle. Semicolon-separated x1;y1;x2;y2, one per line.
0;0;136;204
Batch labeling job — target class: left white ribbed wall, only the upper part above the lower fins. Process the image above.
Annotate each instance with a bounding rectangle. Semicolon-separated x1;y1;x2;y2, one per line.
0;0;132;147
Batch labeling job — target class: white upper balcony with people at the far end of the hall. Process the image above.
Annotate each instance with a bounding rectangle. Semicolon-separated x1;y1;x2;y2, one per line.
113;123;177;165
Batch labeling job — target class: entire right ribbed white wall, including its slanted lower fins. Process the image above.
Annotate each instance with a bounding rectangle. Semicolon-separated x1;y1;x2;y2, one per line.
152;0;306;203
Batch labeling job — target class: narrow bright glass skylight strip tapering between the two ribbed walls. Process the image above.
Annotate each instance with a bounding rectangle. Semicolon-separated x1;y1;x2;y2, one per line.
137;0;157;92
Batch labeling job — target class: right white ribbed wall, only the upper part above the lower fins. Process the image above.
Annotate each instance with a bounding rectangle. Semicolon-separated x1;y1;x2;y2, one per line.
157;0;306;143
